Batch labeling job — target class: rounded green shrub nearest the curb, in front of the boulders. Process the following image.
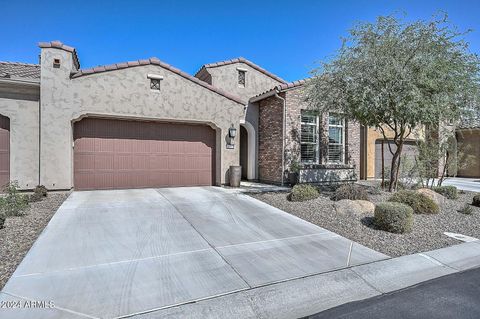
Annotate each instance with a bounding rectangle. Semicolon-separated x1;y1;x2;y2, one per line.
374;202;413;234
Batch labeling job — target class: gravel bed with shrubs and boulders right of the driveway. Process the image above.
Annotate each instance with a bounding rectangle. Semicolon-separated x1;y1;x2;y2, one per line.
250;192;480;257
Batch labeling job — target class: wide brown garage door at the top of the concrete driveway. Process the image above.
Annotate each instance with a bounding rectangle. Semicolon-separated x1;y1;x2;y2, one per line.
74;118;215;190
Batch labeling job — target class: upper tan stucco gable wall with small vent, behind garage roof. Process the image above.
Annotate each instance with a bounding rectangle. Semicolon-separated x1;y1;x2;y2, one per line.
207;62;281;105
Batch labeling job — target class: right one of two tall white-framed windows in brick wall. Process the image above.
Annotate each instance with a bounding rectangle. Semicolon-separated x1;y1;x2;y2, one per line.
327;113;345;163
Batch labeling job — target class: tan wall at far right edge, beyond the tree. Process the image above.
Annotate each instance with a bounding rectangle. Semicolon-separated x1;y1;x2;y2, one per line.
457;129;480;177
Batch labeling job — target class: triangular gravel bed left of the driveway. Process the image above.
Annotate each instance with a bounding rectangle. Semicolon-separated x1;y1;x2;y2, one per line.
0;192;69;290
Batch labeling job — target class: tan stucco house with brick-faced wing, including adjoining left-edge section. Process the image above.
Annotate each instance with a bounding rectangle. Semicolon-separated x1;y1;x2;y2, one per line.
0;41;360;190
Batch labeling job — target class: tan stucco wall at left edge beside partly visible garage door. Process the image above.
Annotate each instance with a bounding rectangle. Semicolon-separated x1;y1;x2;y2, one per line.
0;98;39;189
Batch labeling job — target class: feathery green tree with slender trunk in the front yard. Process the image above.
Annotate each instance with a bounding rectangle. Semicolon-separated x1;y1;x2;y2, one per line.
309;15;480;191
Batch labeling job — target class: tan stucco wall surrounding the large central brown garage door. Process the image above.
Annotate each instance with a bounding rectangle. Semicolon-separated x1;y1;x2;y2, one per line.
41;48;244;189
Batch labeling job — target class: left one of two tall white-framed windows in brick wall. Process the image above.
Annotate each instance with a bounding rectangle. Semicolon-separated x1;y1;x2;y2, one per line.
300;110;319;163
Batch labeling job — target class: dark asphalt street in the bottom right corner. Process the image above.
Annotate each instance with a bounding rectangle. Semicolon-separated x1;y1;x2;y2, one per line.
307;268;480;319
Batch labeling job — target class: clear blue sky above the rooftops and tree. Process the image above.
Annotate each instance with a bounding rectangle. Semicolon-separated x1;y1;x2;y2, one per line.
0;0;480;81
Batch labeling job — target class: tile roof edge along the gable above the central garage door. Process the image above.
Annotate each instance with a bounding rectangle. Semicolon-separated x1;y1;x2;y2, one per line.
71;57;246;105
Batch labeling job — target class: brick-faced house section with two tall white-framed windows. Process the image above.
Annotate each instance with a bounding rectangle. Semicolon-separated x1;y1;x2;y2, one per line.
250;80;360;183
